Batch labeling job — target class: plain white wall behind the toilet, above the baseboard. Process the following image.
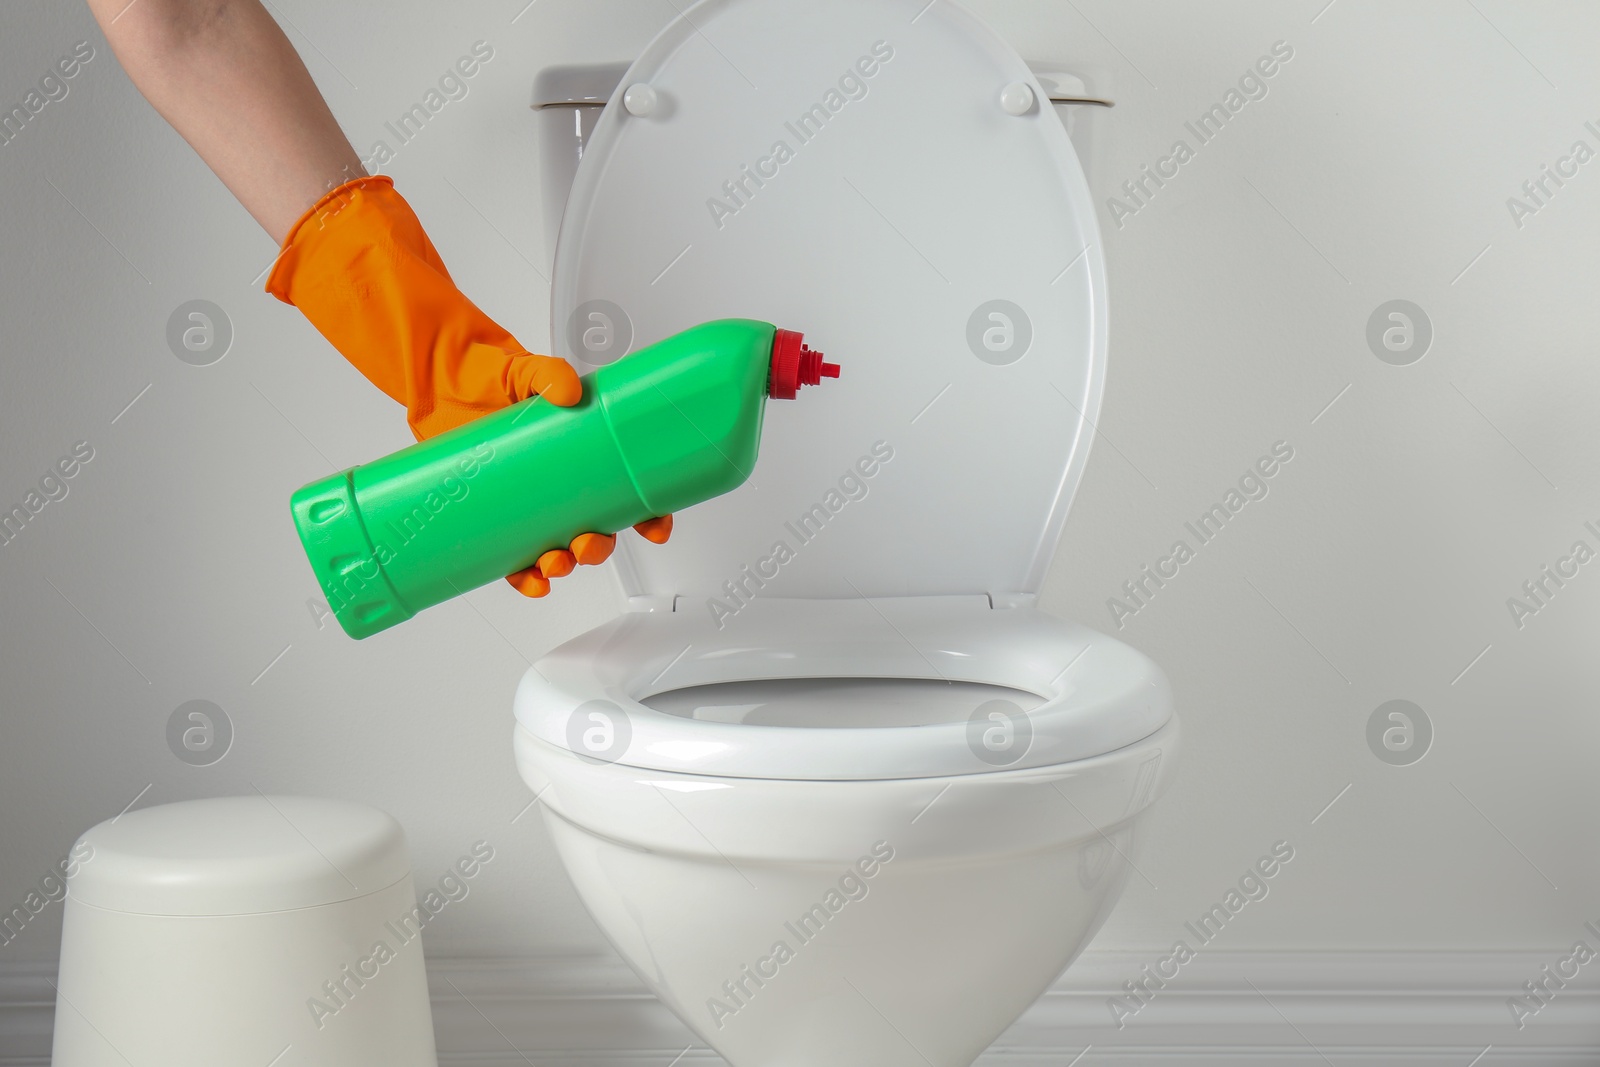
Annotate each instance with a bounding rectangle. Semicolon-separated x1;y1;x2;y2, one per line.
0;0;1600;992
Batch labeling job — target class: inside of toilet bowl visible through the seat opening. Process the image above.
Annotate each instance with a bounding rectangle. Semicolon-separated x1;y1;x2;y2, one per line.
638;678;1045;729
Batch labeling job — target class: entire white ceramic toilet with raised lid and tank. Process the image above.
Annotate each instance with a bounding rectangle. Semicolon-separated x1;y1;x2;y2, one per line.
514;0;1178;1067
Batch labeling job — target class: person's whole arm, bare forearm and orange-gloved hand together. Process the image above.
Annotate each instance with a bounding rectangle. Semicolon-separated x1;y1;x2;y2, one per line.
88;0;672;597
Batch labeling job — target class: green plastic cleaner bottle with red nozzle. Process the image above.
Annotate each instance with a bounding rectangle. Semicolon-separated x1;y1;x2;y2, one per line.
290;318;838;638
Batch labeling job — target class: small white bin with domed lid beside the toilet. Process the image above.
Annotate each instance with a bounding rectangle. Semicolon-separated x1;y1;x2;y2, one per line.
51;795;438;1067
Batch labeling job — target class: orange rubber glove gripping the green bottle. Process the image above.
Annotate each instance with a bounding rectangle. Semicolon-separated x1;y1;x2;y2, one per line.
267;176;672;597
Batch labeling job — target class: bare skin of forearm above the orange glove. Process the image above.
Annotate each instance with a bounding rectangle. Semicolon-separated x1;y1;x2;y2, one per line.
88;0;366;245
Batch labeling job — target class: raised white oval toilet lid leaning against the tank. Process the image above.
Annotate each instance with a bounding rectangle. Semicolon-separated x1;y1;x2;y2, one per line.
552;0;1106;611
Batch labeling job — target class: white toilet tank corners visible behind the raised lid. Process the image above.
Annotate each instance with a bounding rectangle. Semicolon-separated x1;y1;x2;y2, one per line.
533;59;1114;264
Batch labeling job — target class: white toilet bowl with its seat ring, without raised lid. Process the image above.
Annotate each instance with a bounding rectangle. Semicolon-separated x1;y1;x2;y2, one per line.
515;598;1178;1067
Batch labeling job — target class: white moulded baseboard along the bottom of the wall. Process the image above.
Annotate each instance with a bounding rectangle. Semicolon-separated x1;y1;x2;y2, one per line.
0;950;1600;1067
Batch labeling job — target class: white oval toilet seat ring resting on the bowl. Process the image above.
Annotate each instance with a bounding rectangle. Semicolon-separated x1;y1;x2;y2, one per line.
515;597;1173;781
